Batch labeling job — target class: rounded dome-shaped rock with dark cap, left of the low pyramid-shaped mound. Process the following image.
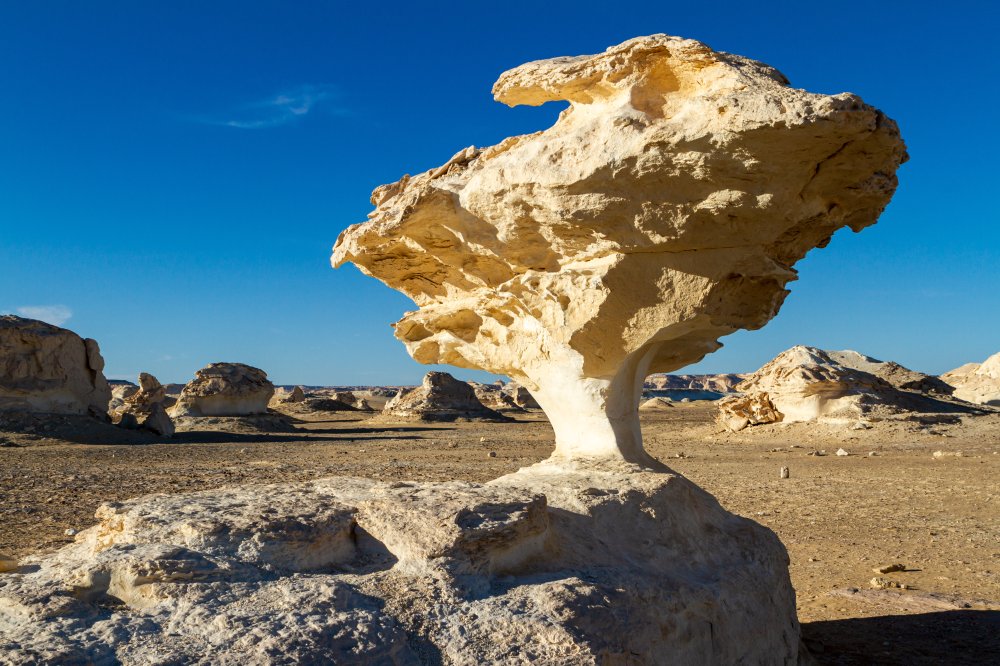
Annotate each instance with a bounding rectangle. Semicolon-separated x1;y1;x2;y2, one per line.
170;363;274;418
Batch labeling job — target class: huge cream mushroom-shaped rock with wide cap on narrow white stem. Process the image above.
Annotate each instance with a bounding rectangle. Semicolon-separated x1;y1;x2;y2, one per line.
332;35;906;462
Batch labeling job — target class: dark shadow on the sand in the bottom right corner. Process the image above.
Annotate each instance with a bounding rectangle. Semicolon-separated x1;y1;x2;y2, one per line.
802;610;1000;666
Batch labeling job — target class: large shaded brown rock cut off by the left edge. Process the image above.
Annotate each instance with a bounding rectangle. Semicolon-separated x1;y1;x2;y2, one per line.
0;315;111;418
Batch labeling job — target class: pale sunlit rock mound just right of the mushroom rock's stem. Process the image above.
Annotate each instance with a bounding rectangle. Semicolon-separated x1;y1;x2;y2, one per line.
718;345;974;430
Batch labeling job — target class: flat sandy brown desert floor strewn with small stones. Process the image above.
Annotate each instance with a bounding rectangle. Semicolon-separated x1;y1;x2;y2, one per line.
0;402;1000;664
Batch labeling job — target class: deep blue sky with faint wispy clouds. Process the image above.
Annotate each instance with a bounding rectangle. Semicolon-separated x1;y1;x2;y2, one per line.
0;0;1000;384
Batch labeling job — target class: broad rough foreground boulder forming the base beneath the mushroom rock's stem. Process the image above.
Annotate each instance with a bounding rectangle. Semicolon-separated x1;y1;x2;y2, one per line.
0;463;798;666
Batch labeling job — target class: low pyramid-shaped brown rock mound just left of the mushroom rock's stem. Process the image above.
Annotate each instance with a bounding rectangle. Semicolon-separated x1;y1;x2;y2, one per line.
381;372;510;421
